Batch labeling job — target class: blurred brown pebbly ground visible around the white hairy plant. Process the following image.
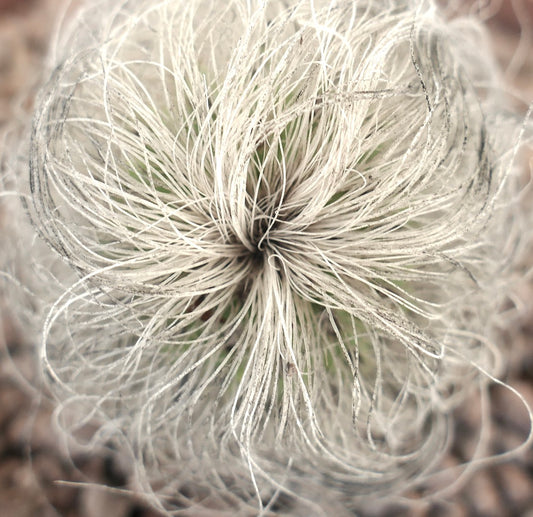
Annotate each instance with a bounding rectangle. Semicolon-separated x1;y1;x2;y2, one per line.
0;0;533;517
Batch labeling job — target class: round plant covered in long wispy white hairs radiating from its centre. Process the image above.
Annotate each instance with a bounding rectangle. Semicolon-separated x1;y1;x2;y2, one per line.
13;0;528;515
